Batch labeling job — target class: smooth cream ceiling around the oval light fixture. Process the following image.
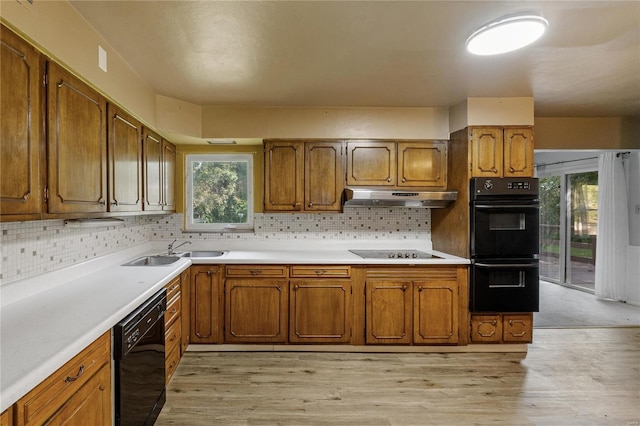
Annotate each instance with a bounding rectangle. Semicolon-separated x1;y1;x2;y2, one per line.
71;0;640;117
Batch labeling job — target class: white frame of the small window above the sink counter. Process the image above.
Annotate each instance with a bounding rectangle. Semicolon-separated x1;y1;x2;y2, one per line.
184;153;254;232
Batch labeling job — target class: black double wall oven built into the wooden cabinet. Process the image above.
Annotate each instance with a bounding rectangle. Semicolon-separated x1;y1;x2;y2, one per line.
469;178;540;312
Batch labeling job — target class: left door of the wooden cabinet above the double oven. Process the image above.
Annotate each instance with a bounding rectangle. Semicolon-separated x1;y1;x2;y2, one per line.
471;128;503;177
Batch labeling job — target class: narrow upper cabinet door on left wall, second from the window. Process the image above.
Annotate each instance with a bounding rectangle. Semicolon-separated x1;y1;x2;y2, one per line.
142;128;162;211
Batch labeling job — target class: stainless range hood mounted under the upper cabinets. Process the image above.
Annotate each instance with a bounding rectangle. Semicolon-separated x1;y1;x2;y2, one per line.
344;187;458;209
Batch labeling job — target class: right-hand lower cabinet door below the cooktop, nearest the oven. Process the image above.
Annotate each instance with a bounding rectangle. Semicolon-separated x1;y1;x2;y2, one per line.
413;281;458;344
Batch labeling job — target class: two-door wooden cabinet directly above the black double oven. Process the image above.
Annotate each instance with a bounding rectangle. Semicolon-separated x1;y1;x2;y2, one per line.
470;127;533;177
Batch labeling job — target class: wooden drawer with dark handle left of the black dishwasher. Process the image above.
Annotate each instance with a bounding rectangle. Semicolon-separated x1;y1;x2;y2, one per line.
16;331;111;425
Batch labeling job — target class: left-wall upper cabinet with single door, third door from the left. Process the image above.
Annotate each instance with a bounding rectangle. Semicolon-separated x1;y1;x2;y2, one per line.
107;104;142;212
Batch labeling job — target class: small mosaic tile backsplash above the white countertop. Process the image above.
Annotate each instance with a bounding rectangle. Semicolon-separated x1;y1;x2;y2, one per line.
0;208;431;284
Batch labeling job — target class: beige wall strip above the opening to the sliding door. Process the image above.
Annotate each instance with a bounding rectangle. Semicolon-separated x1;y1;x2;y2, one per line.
535;117;640;149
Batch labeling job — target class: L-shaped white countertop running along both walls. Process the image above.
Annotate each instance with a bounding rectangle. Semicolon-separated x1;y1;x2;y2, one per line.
0;241;469;412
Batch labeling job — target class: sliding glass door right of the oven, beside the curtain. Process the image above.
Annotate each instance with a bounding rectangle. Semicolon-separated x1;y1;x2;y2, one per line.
540;171;598;292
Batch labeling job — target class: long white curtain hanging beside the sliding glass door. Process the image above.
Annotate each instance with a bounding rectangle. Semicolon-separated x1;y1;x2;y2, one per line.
595;152;629;301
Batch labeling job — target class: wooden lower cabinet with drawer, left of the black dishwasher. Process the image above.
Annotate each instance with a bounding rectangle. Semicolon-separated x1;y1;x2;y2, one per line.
14;331;112;426
